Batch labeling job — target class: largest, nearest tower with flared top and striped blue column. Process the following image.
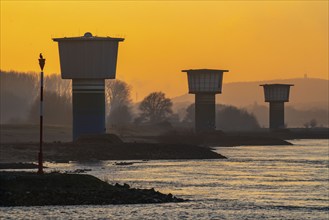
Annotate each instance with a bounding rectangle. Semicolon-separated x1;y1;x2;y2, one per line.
53;32;124;140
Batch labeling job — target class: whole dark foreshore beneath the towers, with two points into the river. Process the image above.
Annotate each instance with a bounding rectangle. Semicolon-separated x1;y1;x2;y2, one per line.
0;132;298;163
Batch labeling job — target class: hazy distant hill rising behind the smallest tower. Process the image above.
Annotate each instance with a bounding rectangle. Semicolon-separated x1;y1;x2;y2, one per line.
172;78;329;127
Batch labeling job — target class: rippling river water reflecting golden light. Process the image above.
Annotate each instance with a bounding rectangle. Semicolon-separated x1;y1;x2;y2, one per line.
0;140;329;219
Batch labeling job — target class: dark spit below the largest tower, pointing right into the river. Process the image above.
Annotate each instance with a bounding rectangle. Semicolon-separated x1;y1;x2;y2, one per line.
0;142;226;163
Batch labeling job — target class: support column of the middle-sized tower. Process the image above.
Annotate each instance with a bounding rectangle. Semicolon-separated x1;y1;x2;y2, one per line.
195;93;216;132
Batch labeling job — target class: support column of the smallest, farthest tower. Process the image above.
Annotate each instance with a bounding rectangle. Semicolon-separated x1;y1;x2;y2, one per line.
270;102;285;129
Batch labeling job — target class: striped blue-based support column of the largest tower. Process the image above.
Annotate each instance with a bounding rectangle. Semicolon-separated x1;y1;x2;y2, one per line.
72;79;106;140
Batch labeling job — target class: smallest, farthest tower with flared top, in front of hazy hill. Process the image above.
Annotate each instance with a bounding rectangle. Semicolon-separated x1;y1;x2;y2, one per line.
260;84;293;129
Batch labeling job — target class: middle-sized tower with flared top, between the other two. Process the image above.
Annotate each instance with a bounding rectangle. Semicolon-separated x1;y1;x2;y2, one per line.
182;69;228;132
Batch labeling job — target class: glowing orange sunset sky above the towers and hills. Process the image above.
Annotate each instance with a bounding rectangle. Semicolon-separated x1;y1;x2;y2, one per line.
0;1;328;101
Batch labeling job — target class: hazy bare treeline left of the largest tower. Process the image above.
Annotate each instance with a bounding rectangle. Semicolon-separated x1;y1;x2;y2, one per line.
0;71;72;125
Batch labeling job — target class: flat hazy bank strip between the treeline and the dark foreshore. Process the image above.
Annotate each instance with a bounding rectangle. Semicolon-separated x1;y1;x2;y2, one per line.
0;124;329;146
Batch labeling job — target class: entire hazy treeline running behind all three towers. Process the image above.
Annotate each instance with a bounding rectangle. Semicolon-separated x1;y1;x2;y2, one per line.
0;71;328;130
